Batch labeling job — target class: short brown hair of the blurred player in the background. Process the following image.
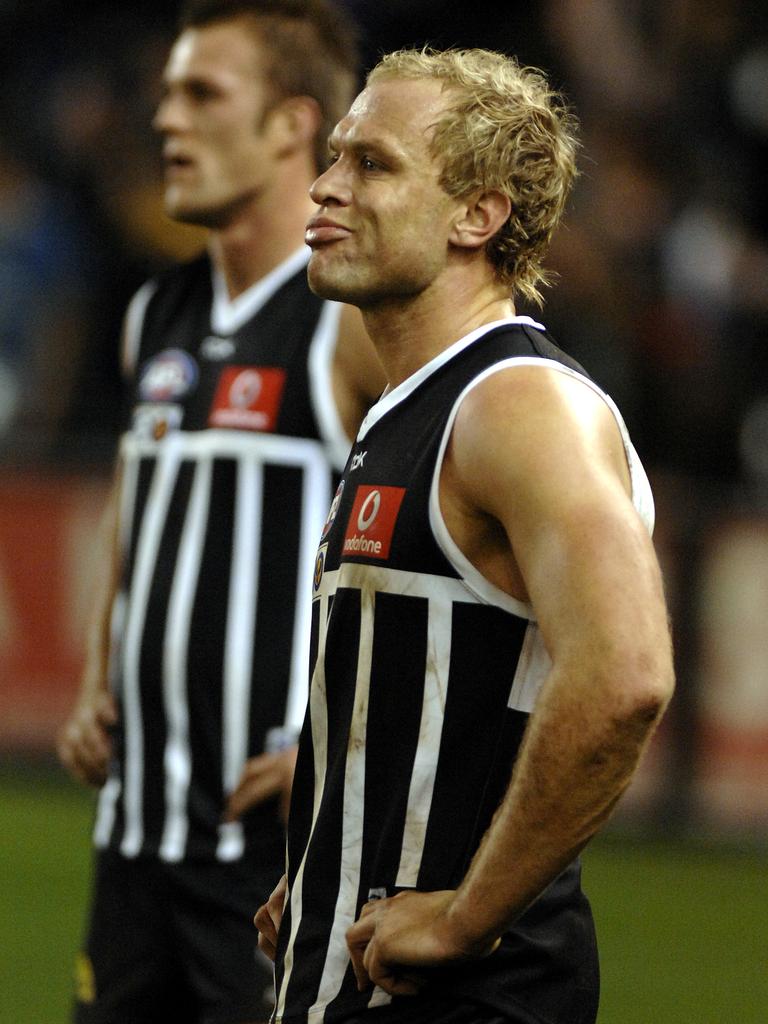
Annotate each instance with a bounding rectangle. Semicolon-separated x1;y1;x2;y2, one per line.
179;0;359;173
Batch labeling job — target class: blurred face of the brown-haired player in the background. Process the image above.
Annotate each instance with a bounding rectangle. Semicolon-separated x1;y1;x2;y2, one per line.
155;22;273;228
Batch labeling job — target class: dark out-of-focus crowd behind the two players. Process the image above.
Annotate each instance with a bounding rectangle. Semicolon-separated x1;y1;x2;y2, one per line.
0;0;768;827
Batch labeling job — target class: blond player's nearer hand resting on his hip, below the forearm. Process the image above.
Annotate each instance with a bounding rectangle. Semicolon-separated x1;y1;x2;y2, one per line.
347;890;500;995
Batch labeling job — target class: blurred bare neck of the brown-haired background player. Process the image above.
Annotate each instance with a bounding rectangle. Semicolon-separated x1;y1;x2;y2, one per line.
208;167;316;299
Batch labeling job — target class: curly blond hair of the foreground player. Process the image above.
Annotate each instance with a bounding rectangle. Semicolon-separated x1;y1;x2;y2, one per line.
367;47;579;306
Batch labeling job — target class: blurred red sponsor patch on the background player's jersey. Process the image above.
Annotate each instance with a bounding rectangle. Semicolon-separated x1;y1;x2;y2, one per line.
208;367;286;430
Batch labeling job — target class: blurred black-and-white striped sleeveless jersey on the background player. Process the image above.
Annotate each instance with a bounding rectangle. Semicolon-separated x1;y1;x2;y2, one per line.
95;250;349;864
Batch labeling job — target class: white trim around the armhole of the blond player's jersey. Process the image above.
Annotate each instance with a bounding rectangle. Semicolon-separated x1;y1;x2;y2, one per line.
429;356;654;622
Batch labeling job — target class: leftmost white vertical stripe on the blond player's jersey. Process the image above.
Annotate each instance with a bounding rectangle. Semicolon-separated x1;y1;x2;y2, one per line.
275;585;336;1020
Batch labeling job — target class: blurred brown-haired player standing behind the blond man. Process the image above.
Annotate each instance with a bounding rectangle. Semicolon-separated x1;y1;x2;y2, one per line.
59;0;382;1024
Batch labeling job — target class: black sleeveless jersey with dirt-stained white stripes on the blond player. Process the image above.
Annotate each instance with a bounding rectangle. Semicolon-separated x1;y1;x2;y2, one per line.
275;317;652;1024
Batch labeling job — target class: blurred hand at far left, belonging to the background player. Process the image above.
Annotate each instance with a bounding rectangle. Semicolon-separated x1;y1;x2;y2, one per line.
56;690;118;785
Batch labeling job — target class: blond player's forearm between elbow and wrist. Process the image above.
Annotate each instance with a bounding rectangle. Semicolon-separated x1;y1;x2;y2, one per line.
450;663;665;948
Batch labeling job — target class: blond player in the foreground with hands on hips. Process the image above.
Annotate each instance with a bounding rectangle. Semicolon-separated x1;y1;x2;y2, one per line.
256;51;673;1024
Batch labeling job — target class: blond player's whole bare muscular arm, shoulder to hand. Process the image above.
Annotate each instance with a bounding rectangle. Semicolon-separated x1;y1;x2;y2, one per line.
348;368;673;992
